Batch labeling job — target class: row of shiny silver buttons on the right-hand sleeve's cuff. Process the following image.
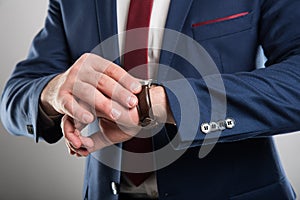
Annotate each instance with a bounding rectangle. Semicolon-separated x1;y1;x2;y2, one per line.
201;118;235;134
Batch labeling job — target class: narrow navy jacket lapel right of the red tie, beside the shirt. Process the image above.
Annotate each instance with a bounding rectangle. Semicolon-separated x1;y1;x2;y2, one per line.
157;0;193;81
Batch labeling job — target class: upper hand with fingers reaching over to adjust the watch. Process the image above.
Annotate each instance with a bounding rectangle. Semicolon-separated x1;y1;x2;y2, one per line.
40;54;141;155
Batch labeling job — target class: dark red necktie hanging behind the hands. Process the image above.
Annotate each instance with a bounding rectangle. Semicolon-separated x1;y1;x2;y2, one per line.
123;0;153;186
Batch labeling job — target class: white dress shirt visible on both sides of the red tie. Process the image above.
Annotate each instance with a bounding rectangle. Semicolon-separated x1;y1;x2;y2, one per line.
117;0;171;198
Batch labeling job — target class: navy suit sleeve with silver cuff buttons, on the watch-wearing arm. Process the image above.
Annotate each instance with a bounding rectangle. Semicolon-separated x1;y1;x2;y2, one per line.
163;0;300;149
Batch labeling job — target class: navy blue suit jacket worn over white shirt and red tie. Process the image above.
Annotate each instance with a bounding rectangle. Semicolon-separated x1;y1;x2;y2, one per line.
1;0;300;200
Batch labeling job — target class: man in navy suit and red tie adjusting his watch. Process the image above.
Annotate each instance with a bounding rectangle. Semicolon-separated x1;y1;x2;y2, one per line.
1;0;300;200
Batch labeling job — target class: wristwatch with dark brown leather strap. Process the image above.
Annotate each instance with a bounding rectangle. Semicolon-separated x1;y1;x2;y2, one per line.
136;79;158;127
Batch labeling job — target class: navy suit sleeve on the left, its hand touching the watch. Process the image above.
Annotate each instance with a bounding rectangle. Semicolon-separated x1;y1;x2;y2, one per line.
1;0;70;143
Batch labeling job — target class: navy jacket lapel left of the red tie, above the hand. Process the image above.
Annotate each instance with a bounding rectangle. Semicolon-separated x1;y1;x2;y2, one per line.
93;0;120;64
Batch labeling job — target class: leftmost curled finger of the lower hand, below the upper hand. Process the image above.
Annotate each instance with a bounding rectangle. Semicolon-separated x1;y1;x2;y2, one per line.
61;115;82;149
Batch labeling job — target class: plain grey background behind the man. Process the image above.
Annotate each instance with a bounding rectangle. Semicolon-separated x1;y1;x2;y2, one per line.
0;0;300;200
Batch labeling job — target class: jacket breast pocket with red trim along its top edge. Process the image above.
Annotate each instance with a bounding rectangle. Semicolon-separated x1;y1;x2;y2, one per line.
192;12;253;41
